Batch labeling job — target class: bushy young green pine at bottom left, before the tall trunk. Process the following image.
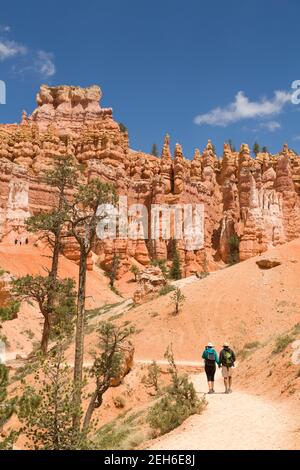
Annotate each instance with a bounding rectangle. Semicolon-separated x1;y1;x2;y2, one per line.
18;341;86;450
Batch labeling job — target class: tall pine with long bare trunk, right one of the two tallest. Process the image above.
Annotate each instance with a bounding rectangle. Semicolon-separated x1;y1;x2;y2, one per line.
67;179;116;435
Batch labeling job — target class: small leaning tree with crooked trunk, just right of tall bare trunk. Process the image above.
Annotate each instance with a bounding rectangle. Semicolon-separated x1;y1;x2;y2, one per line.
83;322;134;433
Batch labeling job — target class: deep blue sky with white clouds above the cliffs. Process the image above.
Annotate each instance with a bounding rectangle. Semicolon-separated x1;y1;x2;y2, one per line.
0;0;300;158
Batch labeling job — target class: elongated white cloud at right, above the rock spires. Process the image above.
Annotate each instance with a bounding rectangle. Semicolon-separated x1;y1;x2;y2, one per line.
194;91;292;127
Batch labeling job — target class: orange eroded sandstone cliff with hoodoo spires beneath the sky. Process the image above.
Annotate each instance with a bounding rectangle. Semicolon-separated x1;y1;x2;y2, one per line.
0;85;300;275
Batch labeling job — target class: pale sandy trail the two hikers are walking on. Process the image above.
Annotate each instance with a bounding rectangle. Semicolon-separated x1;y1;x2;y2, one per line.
151;372;299;450
